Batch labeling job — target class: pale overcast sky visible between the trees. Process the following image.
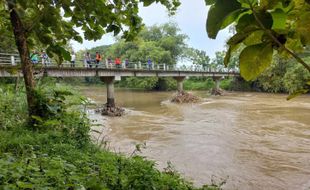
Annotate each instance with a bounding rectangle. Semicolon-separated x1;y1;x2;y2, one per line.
72;0;230;57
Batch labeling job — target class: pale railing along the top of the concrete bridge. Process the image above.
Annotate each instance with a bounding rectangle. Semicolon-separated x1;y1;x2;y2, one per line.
0;53;239;73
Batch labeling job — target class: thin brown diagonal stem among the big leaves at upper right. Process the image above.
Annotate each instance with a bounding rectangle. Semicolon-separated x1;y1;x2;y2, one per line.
247;0;310;72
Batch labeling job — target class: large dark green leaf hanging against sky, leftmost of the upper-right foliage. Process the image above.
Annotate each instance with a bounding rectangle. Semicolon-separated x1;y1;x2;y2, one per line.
206;0;242;39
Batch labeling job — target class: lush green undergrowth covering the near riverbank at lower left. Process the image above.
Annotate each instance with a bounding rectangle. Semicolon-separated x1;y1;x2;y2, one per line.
0;79;219;189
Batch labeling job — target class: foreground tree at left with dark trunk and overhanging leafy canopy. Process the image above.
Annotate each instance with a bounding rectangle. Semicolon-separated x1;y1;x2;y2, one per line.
0;0;180;118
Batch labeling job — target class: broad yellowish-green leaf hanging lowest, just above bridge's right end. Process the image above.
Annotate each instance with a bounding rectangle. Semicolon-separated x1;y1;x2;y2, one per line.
239;43;273;81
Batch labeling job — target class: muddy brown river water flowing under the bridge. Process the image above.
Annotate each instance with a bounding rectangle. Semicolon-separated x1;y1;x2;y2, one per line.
82;87;310;190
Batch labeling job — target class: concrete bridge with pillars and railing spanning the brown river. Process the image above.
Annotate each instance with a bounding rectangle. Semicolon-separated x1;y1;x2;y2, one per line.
0;54;240;107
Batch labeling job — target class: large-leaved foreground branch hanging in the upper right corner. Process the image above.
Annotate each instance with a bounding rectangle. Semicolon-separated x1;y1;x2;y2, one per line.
205;0;310;89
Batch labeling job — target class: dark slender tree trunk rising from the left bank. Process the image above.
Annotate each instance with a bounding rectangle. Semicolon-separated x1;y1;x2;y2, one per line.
7;1;37;120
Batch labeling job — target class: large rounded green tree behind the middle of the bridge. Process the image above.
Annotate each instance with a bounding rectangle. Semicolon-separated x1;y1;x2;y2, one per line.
83;23;187;65
